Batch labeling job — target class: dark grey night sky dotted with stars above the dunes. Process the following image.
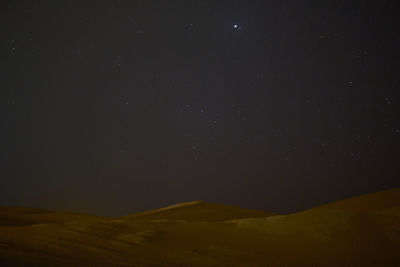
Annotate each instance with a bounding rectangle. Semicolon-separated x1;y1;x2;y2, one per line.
0;0;400;218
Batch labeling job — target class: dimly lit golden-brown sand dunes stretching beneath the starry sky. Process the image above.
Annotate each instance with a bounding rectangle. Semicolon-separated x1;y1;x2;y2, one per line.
0;188;400;266
